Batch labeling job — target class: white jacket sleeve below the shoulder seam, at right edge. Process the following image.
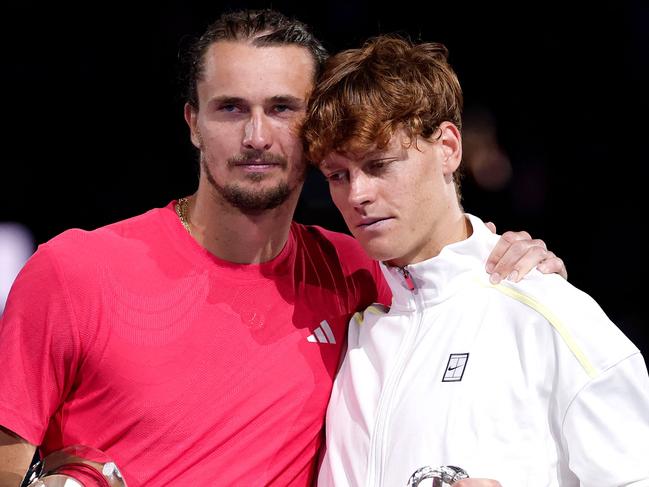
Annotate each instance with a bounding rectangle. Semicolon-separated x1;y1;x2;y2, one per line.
562;353;649;487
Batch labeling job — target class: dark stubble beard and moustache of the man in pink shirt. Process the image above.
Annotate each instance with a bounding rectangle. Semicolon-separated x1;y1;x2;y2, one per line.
200;151;306;213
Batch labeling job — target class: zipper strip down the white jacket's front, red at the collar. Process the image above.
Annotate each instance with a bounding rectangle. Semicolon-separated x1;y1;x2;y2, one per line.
366;267;423;487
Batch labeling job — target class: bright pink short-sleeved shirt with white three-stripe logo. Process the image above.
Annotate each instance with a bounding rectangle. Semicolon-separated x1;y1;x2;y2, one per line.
0;204;389;487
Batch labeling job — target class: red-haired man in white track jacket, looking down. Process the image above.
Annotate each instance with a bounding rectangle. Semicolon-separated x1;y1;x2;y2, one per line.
304;36;649;487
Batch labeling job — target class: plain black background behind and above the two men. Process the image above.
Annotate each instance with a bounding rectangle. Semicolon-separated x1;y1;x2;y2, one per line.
0;1;649;356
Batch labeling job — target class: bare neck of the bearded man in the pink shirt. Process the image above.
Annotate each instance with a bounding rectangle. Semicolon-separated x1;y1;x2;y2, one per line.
182;180;300;264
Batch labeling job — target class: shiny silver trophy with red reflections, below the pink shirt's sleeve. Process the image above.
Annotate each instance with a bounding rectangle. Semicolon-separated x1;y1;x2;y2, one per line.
23;445;127;487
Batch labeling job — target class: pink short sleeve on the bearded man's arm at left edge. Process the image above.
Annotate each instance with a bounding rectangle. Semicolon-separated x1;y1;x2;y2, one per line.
0;245;79;445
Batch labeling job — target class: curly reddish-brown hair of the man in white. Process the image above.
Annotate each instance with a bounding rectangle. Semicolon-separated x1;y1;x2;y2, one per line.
302;36;462;165
